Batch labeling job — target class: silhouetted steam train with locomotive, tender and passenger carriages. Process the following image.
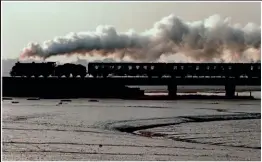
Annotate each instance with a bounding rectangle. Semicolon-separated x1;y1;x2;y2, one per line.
10;62;261;78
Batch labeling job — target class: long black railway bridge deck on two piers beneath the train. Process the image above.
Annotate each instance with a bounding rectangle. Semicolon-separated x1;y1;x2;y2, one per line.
3;77;261;97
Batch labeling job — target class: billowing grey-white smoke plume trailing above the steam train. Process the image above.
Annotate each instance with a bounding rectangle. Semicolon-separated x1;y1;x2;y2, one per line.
20;15;261;62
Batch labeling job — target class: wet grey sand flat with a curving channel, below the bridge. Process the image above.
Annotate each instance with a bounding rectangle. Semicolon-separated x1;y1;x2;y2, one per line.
2;95;261;161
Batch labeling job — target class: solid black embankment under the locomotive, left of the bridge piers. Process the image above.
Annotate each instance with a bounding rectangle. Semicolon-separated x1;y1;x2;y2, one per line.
3;77;144;99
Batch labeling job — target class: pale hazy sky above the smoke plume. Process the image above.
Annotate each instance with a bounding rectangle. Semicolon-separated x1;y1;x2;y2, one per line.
1;2;261;58
